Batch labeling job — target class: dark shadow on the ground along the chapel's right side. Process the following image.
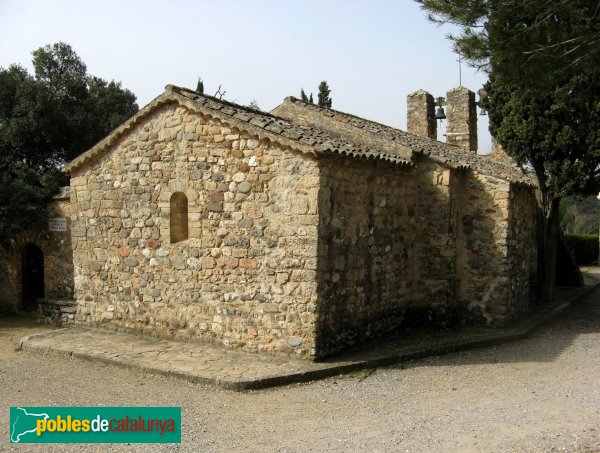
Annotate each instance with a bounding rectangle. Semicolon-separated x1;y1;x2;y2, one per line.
323;268;600;368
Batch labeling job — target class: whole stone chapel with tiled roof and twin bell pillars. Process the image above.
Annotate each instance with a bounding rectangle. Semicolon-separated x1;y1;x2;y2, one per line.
0;85;537;359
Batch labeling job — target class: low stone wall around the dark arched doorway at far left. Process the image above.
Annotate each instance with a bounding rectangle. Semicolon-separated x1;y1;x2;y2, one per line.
0;188;73;316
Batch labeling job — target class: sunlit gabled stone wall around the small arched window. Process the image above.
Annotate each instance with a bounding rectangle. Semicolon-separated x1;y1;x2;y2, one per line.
71;104;319;356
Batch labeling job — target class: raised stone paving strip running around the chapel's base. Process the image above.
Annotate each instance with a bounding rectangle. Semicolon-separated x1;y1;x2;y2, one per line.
21;274;600;390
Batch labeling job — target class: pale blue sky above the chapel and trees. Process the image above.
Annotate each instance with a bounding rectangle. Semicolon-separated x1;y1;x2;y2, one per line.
0;0;490;152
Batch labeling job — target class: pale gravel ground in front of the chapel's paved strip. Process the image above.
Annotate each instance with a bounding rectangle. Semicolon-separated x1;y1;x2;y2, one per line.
0;290;600;452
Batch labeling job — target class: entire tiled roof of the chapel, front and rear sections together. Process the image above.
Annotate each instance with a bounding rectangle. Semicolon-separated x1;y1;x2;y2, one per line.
65;85;532;184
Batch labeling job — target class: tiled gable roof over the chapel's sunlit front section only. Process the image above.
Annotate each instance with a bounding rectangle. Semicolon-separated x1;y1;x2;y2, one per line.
65;85;410;172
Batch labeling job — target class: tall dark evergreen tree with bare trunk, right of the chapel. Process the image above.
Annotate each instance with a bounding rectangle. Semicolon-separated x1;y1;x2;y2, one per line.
417;0;600;302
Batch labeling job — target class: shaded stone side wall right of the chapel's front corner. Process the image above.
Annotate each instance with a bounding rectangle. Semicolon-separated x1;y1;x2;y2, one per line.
317;153;464;356
